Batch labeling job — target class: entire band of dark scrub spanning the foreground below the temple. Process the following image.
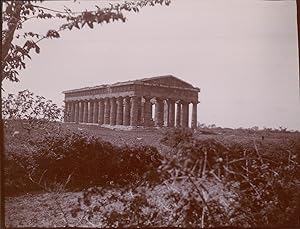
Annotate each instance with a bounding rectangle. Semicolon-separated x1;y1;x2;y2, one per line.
5;120;300;227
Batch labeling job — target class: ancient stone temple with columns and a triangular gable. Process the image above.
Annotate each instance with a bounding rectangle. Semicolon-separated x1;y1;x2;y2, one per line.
63;75;200;128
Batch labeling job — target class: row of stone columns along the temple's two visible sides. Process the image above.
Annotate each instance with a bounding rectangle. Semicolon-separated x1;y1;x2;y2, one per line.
65;96;197;128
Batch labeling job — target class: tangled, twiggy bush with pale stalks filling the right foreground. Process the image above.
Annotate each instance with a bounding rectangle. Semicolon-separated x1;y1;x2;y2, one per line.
72;129;300;227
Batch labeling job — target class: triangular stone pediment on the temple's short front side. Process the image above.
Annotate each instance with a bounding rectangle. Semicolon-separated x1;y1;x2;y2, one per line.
139;75;194;88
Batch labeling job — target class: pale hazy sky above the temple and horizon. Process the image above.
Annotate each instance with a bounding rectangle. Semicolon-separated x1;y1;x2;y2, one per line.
4;0;300;130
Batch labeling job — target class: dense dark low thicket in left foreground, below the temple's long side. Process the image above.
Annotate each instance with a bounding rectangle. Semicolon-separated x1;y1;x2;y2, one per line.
5;131;162;194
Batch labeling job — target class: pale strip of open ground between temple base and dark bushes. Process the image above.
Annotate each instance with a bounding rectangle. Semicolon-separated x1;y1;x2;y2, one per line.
65;124;300;150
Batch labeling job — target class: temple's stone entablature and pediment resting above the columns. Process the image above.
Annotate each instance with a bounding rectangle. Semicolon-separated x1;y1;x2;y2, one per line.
64;75;200;102
